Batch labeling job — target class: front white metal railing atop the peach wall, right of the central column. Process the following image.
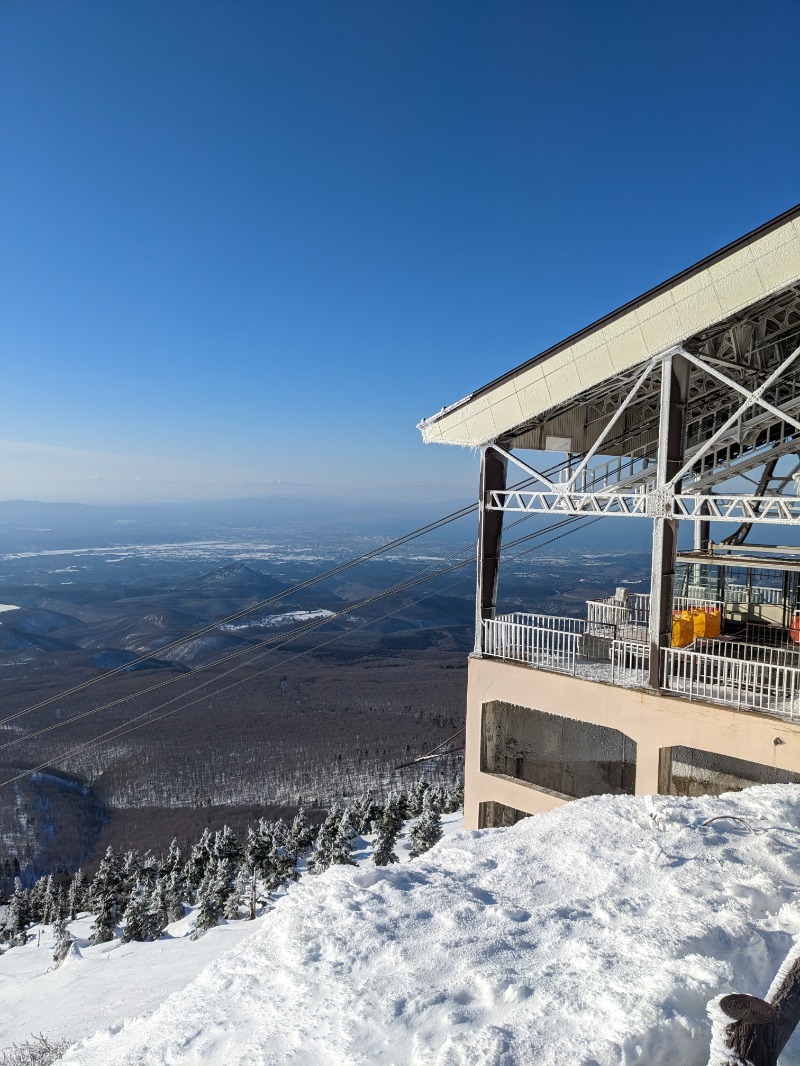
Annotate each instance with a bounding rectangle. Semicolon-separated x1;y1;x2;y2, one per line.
661;648;800;720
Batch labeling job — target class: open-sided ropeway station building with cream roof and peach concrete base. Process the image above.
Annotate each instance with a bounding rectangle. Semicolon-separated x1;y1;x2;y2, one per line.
420;207;800;827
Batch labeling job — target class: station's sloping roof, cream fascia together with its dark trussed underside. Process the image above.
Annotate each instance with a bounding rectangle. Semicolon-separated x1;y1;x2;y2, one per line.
419;206;800;455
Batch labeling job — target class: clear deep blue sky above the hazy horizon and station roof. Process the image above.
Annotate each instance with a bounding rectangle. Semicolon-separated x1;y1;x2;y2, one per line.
0;0;800;502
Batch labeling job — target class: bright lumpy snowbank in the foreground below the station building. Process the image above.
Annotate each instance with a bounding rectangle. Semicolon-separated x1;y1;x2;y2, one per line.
57;786;800;1066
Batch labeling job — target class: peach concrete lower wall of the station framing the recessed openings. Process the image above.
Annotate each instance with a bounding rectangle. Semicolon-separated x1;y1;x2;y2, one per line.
464;656;800;828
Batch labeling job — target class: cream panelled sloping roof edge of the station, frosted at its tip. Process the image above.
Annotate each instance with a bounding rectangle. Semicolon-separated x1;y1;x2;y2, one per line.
418;205;800;450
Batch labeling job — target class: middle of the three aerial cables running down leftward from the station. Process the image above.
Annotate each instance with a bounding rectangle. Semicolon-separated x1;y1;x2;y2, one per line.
0;516;578;750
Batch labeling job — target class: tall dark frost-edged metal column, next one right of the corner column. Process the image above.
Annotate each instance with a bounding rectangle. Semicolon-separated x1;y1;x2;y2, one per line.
650;355;689;689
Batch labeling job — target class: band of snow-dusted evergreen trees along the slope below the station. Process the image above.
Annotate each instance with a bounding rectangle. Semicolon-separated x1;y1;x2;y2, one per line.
0;780;463;963
